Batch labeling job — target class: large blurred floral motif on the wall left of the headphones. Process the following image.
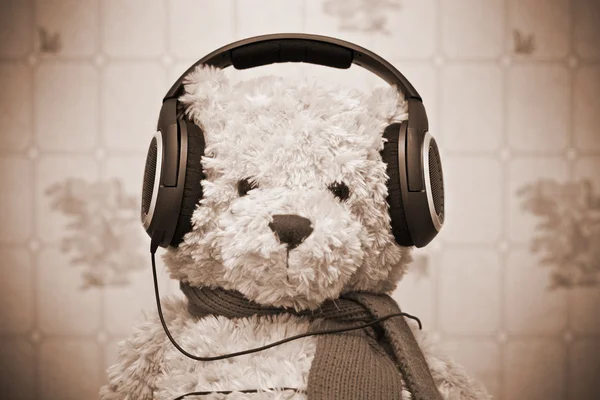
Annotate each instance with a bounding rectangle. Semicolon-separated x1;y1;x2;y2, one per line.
46;179;146;289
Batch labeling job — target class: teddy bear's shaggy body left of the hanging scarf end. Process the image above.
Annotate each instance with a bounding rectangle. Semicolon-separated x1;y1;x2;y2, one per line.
101;298;316;400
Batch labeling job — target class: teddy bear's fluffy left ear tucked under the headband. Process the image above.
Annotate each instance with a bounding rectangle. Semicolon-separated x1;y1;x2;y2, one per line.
179;65;230;118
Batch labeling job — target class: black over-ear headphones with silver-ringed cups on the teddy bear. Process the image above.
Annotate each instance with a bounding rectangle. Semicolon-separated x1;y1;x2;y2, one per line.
141;34;444;252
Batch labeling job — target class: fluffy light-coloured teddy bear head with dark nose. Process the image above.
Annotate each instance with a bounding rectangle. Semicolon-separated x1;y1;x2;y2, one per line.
164;67;411;310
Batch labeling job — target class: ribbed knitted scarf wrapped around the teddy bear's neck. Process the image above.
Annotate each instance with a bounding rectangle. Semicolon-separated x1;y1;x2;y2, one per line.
180;282;441;400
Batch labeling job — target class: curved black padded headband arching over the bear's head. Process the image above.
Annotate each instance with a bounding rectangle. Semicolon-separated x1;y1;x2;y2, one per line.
163;33;421;101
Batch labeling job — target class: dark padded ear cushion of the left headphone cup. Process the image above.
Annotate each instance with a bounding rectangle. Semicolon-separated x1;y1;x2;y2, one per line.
170;117;205;247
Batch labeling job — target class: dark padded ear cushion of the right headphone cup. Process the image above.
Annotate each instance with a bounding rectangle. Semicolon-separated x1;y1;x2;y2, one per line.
381;121;413;246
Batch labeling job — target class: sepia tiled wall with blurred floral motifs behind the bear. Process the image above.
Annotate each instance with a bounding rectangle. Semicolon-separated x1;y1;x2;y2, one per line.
0;0;600;400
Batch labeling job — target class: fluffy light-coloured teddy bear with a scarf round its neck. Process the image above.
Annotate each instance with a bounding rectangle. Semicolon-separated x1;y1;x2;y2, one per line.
100;61;490;400
